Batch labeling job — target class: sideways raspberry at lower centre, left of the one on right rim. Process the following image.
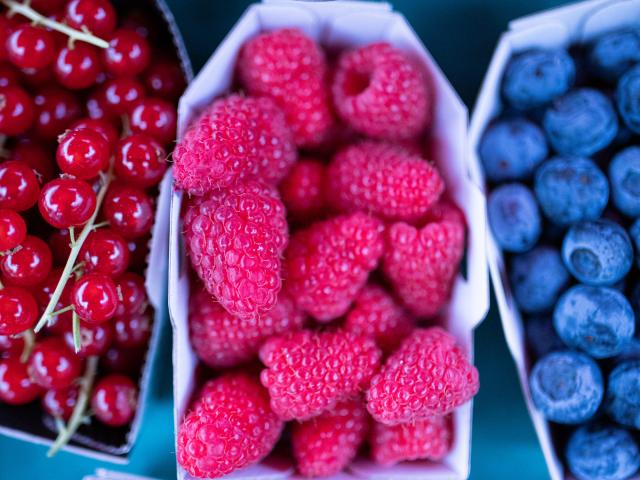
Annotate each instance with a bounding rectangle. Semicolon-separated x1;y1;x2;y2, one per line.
260;330;381;420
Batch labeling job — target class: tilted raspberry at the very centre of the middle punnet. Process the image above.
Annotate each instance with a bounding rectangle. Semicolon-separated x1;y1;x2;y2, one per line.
284;213;383;322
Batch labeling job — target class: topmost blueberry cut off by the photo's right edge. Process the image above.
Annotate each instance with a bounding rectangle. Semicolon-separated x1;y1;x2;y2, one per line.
589;28;640;82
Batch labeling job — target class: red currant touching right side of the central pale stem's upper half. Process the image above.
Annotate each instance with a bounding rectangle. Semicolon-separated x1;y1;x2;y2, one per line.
103;185;153;240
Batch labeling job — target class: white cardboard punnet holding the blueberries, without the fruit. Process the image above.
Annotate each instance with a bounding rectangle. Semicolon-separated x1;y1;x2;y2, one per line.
469;0;640;480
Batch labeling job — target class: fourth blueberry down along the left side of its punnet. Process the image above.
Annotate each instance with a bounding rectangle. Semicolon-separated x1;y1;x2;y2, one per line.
509;246;569;313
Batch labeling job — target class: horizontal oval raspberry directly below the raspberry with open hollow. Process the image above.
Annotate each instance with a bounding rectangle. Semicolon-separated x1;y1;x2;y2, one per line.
327;141;444;222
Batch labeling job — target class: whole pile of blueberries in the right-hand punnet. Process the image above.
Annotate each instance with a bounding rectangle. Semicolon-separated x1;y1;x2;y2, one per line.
479;29;640;480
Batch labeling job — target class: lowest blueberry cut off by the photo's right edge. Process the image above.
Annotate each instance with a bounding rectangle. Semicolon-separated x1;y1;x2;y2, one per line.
606;360;640;429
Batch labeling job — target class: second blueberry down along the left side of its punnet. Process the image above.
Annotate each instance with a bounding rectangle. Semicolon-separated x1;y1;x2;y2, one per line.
480;118;549;182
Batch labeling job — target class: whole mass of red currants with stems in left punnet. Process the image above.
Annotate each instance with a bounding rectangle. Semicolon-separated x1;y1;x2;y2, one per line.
0;0;184;456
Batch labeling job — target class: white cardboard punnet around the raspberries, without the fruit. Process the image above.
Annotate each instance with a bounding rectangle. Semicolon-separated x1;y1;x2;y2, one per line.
169;1;489;479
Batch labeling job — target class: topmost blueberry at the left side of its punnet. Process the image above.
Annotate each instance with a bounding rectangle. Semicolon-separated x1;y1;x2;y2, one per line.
502;50;576;110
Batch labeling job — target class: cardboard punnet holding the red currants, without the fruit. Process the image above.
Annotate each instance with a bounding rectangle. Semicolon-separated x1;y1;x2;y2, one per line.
0;0;193;464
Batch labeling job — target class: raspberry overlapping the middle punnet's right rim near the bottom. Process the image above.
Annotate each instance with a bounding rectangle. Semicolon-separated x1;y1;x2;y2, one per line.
367;327;480;425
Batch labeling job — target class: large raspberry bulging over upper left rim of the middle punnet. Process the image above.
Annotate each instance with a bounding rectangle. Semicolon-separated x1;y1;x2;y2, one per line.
173;95;297;195
